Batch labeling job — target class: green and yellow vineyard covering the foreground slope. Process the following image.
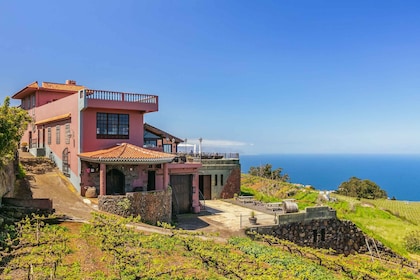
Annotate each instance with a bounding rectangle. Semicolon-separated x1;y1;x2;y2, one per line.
0;214;419;279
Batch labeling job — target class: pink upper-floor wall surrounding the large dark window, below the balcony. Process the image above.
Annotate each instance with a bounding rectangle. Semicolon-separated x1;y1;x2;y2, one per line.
80;108;144;153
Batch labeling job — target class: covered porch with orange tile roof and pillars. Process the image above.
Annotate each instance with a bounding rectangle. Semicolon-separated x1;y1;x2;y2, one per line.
79;143;174;196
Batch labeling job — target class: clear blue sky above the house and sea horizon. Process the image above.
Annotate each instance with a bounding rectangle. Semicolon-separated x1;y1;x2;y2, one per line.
0;0;420;154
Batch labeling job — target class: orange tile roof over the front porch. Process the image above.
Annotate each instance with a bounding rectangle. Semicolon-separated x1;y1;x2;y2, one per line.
79;143;175;164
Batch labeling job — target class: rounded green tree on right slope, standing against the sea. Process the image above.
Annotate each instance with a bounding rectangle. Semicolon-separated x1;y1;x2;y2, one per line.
337;177;387;199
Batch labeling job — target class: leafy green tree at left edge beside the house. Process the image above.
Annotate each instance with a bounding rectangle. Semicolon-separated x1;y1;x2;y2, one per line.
0;97;32;164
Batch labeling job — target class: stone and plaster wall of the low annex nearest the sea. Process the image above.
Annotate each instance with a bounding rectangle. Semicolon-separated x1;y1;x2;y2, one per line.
199;159;241;199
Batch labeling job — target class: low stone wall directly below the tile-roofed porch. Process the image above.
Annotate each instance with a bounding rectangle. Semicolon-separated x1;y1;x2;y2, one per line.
98;188;172;224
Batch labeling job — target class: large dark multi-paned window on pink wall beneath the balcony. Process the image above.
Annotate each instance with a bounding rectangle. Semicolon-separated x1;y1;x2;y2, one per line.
96;113;129;139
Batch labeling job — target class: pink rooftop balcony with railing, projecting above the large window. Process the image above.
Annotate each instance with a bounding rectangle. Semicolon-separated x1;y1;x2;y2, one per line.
79;89;158;113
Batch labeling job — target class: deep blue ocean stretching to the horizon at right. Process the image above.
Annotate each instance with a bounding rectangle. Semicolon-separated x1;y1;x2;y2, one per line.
240;154;420;201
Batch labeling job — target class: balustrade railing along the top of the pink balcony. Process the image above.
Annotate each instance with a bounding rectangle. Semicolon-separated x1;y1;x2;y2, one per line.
85;89;158;104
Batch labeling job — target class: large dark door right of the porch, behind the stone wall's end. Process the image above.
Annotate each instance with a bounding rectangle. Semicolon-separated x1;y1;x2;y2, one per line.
170;175;192;214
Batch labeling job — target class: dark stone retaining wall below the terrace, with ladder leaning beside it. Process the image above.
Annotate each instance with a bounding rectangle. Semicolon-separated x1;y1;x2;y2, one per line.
248;207;412;266
